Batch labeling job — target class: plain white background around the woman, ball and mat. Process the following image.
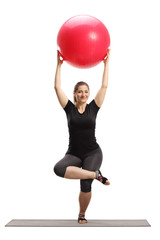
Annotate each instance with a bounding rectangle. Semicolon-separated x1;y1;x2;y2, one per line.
0;0;160;240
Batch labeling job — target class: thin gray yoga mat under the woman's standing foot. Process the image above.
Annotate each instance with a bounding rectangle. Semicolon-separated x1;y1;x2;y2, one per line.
5;219;151;227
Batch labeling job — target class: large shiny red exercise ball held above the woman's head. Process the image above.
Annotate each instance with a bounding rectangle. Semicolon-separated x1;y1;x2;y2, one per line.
57;15;110;68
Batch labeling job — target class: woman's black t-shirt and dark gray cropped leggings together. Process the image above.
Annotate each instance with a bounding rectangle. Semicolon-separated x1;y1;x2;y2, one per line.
54;100;102;192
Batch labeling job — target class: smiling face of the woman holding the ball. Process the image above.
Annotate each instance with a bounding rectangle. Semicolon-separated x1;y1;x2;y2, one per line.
74;85;89;103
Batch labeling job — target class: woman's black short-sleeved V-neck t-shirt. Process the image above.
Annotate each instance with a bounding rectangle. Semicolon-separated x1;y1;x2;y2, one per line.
64;100;100;158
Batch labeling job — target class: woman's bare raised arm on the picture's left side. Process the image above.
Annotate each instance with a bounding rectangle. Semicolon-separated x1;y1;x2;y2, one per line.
54;51;68;108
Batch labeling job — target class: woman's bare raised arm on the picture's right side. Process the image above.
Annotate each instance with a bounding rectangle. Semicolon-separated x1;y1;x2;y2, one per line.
94;50;110;107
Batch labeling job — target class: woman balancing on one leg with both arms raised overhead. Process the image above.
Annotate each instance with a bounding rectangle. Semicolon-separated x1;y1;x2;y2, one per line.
54;51;110;223
